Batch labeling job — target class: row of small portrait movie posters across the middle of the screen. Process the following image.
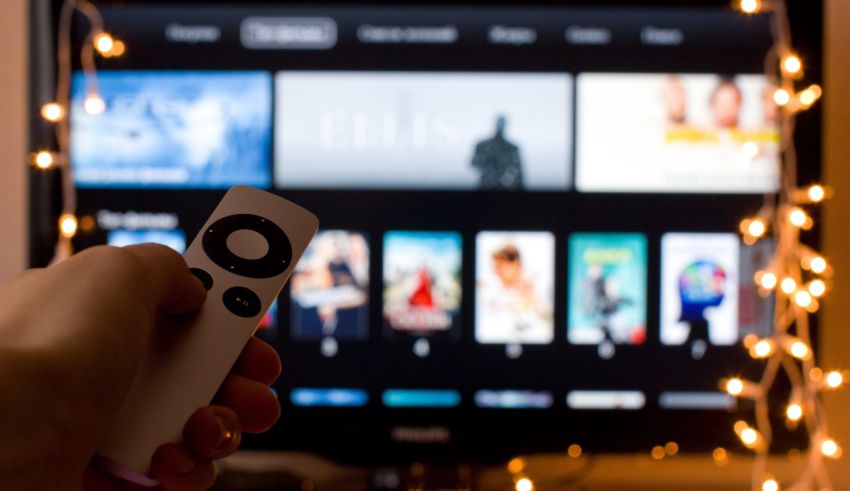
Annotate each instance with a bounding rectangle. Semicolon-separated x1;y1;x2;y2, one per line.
284;230;771;353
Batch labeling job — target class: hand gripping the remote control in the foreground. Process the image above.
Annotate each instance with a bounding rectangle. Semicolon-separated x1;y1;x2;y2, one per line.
0;244;280;491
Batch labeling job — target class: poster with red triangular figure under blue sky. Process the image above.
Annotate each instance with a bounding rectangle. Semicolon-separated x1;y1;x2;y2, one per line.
383;231;462;338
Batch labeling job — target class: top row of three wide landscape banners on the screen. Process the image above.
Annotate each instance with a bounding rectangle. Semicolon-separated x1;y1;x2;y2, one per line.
71;70;779;193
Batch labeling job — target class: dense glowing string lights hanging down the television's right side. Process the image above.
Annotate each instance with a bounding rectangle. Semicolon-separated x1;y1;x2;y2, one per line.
715;0;845;491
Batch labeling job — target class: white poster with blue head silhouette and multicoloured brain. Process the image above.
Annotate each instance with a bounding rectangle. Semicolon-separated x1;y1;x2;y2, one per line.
661;233;740;350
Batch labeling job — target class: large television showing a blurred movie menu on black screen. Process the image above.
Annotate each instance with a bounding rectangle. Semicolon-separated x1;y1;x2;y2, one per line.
30;0;820;465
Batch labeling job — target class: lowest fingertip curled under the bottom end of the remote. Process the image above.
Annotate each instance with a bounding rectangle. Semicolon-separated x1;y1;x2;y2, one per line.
151;443;215;491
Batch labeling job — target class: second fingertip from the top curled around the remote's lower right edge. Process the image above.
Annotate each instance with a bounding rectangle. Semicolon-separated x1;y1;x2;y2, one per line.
216;375;280;433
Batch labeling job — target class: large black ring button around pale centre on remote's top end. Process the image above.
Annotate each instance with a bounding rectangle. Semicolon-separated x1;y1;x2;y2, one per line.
202;214;292;278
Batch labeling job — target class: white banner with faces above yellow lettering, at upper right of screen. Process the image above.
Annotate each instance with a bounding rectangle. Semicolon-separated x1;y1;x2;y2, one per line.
576;73;780;194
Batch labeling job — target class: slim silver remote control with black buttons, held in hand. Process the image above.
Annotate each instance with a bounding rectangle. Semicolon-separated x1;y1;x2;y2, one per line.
93;186;319;486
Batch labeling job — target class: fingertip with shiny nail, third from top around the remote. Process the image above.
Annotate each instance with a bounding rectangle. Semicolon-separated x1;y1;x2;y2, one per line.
183;406;242;460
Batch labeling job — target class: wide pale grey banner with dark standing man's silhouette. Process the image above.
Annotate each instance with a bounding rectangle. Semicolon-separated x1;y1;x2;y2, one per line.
275;71;572;191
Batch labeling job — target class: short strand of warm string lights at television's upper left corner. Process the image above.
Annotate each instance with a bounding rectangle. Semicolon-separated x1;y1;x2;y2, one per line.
32;0;126;262
